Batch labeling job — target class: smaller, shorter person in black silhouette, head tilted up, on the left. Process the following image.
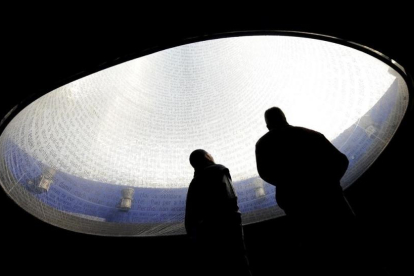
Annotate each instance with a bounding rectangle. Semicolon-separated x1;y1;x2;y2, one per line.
185;149;251;275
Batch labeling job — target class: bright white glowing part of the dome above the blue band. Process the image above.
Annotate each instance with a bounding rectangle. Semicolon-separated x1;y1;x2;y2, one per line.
0;36;402;190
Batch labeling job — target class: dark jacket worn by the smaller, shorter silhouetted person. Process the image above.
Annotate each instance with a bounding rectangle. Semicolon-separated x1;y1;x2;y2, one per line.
185;164;241;238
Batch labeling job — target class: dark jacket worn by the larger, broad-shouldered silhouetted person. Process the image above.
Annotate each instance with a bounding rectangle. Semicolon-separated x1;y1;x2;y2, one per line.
256;125;349;215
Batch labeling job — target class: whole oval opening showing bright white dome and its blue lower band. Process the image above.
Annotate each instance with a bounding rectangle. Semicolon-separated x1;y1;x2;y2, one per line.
0;35;408;236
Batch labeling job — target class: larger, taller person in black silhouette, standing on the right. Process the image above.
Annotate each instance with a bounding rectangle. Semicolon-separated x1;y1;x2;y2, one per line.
256;107;354;275
